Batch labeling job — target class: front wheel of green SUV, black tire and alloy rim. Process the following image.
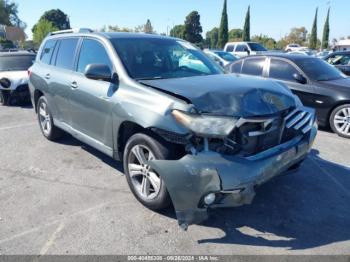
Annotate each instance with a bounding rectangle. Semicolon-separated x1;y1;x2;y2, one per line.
123;133;171;210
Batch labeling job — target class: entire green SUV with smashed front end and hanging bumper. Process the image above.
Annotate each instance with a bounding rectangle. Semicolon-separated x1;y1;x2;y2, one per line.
29;29;317;228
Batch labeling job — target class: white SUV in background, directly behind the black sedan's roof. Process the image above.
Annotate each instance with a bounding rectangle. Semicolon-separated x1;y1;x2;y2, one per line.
224;42;267;57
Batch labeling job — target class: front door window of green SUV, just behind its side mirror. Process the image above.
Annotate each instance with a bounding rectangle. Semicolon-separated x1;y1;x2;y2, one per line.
78;39;112;73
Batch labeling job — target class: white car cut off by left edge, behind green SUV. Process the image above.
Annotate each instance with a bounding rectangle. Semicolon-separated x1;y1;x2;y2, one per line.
0;51;35;106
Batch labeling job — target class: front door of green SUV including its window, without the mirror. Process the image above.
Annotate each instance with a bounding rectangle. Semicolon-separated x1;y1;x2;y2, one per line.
70;38;116;147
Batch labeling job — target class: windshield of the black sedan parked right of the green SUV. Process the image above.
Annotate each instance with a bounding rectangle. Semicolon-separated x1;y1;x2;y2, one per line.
297;58;346;81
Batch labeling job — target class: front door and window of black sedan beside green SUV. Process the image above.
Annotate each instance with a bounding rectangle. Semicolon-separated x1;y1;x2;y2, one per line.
268;58;315;107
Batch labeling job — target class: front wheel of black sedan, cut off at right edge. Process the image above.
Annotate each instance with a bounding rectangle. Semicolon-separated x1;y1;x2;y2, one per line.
329;104;350;138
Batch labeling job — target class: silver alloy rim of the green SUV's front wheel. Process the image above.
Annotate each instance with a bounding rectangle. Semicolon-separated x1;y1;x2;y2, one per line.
128;145;161;200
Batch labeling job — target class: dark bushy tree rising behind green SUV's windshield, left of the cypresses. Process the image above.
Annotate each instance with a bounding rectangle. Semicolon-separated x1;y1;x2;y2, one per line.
184;11;203;43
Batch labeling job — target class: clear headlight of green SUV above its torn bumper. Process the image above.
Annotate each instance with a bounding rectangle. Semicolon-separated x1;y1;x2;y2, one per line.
172;110;237;138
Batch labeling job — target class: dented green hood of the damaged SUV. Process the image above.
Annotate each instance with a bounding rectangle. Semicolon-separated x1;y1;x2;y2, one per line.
141;74;298;117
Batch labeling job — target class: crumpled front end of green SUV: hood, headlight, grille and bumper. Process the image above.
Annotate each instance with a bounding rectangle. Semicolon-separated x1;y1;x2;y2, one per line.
142;75;317;229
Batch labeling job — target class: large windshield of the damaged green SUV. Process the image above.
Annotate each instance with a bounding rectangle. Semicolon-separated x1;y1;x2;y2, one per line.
111;37;223;80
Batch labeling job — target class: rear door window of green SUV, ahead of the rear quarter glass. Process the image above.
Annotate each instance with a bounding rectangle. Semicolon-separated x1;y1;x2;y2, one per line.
56;38;78;70
